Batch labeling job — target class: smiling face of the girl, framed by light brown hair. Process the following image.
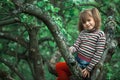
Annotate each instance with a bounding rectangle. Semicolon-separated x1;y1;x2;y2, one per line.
83;16;95;30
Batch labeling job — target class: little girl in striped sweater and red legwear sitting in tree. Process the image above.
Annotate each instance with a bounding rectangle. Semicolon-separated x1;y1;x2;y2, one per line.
56;8;106;80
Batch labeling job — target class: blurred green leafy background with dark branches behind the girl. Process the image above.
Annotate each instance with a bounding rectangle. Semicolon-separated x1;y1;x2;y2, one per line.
0;0;120;80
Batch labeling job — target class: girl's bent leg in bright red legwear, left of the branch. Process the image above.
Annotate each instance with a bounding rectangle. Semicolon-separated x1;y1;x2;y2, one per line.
56;62;71;80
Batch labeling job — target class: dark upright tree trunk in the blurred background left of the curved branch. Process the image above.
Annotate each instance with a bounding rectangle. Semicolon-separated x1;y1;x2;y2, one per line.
28;26;45;80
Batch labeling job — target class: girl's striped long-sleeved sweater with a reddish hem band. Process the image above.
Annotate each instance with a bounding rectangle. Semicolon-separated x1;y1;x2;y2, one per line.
73;30;106;71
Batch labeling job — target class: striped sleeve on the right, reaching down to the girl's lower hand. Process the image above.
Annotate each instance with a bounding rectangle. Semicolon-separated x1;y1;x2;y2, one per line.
86;32;106;71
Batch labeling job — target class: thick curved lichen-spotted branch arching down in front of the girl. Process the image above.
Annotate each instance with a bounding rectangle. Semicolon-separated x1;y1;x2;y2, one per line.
22;4;81;80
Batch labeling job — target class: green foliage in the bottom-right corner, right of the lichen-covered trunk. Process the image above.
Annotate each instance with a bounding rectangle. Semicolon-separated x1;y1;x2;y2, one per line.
105;47;120;80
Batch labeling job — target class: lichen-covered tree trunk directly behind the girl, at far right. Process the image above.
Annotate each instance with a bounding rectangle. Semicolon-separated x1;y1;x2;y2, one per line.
92;16;118;80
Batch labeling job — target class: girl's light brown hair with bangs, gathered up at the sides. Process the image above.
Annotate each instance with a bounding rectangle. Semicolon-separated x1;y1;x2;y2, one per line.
78;8;101;31
